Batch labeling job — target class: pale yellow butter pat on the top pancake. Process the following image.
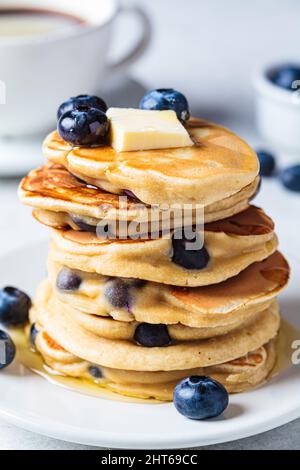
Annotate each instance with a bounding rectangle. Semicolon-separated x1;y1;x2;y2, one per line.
106;108;193;152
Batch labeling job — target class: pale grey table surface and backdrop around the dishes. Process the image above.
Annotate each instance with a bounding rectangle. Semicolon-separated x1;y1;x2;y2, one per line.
0;0;300;450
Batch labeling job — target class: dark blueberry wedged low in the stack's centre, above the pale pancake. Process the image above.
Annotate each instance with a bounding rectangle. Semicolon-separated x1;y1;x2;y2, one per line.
134;323;172;348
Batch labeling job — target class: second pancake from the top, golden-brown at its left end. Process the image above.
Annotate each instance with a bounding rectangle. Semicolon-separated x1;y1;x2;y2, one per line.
19;164;259;232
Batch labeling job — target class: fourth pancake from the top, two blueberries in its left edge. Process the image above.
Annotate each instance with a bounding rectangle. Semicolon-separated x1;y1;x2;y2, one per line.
48;252;289;328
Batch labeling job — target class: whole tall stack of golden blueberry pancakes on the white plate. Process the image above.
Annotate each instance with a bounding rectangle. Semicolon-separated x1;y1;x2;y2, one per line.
20;119;289;400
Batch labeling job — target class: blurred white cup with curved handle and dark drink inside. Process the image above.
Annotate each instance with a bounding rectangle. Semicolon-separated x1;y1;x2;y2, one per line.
0;0;151;137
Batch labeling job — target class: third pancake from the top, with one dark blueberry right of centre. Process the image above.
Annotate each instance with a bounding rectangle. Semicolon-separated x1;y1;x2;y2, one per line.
49;206;278;287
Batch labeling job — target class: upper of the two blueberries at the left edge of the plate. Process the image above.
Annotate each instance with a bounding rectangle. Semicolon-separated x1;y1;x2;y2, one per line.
0;287;31;327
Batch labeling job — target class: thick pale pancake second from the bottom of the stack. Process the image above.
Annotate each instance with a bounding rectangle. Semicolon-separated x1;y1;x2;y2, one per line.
30;284;280;372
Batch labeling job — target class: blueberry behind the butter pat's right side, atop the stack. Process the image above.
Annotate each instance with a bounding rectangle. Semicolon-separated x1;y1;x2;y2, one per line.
140;88;190;122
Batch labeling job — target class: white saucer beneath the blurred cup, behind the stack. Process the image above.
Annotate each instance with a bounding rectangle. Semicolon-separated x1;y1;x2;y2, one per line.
0;77;145;178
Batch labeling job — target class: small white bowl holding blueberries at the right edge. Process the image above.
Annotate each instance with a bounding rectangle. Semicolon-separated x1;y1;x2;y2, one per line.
254;64;300;151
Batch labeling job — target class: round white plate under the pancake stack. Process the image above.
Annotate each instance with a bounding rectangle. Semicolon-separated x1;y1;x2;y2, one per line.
0;243;300;449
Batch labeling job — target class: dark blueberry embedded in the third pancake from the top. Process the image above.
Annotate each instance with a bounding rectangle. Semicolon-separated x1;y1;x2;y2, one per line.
172;231;210;269
